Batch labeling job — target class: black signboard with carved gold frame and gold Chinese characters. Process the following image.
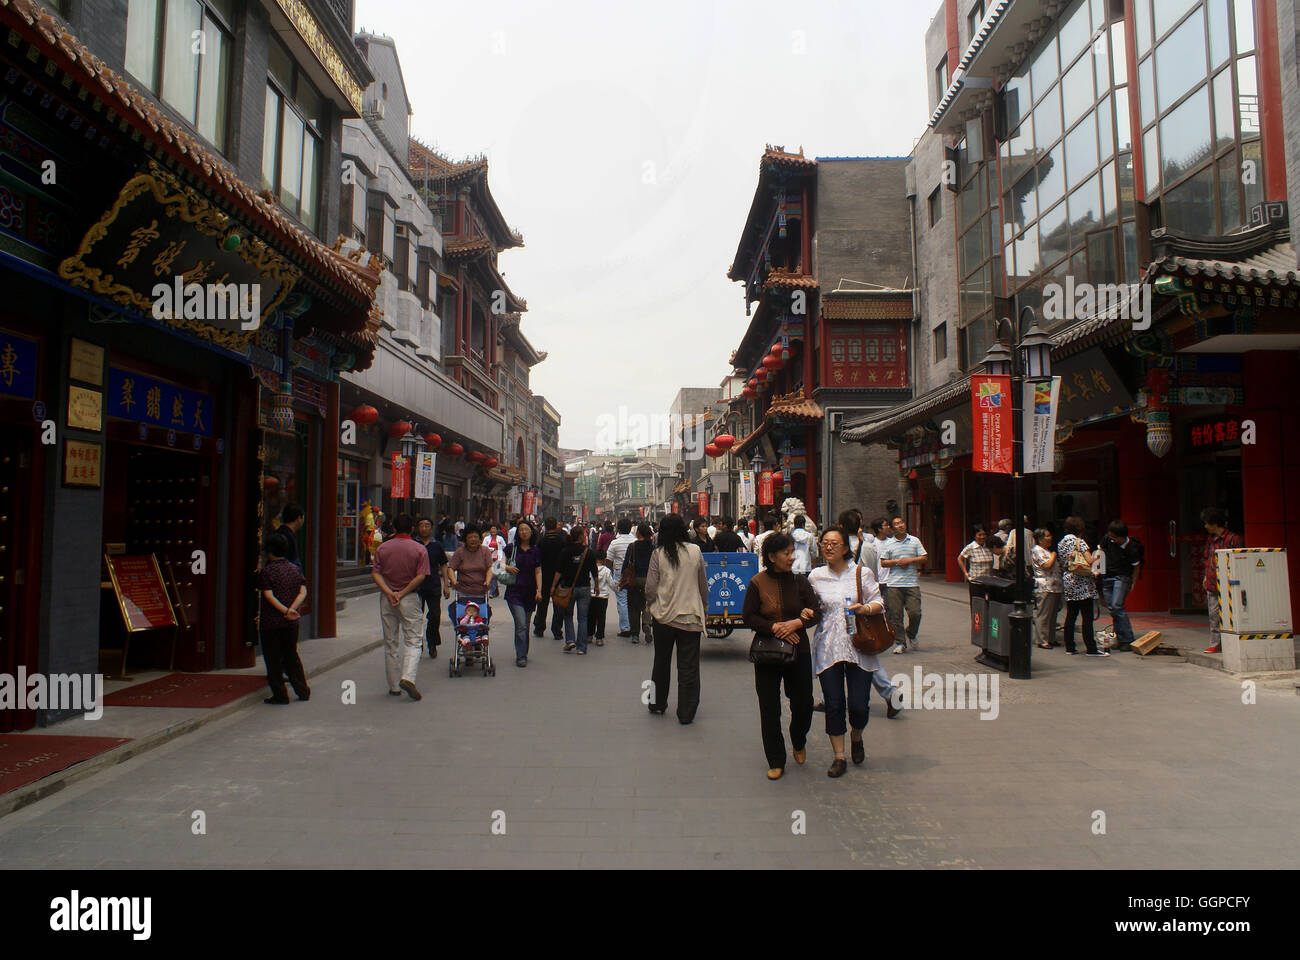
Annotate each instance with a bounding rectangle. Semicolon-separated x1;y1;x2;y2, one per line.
59;160;302;353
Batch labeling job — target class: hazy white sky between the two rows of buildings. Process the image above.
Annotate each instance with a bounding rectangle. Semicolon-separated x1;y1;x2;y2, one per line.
356;0;941;447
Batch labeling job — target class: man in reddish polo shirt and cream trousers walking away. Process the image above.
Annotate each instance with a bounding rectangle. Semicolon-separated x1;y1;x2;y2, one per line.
371;514;429;700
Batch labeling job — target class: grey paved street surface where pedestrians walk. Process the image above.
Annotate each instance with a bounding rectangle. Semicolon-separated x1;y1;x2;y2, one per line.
0;582;1300;868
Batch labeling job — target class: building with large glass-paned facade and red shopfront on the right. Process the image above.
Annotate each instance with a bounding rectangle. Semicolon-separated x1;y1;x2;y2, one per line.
845;0;1300;610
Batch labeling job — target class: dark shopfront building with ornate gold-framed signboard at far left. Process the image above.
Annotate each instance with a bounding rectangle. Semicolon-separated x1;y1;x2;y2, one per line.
0;0;378;728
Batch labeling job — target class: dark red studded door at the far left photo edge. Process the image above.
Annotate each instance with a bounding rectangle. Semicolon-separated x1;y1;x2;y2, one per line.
0;424;40;732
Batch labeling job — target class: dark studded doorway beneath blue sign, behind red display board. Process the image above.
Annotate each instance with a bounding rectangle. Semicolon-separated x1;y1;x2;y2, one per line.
100;440;221;671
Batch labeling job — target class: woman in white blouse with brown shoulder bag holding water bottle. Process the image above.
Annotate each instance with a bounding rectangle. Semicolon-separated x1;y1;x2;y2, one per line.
809;527;885;777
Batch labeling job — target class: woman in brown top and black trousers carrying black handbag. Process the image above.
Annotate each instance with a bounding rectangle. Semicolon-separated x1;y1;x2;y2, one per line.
744;533;822;780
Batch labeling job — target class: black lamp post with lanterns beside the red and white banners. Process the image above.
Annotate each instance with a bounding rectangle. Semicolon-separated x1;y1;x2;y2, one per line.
984;307;1052;680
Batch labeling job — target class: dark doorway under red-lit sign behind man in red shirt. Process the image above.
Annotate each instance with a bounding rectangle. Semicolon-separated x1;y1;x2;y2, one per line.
1175;450;1244;613
